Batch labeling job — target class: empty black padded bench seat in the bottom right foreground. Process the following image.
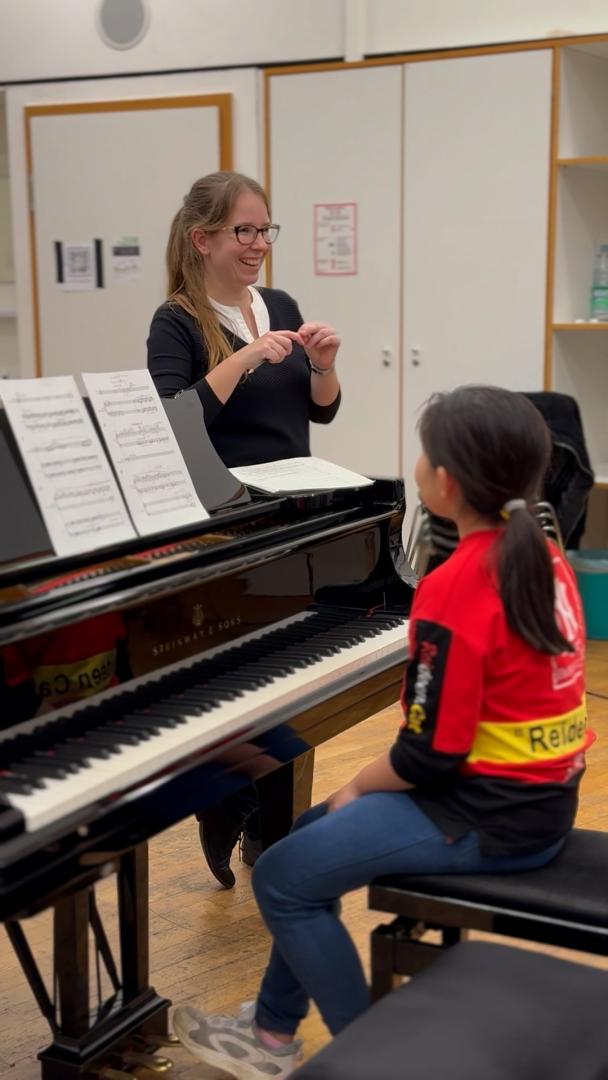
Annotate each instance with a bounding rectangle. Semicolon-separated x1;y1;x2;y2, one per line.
293;942;608;1080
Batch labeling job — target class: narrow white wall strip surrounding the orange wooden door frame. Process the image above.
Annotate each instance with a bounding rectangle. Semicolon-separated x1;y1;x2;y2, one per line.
6;68;261;378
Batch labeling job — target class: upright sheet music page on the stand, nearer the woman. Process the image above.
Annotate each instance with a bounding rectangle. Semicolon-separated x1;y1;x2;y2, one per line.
82;368;210;536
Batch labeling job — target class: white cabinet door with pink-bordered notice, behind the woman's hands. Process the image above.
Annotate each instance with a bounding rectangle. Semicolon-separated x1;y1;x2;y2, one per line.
270;66;403;475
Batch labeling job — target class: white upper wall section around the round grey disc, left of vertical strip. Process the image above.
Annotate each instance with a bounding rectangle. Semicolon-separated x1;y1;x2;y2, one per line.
0;0;349;83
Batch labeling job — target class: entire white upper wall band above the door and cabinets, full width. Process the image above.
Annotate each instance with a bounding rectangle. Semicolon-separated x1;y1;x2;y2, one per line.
0;0;608;83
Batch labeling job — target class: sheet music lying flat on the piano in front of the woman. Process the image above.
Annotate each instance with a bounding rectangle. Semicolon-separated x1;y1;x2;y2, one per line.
230;458;374;495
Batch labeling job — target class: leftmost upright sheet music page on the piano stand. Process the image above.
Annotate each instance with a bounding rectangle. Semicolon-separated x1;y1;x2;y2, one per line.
0;375;135;555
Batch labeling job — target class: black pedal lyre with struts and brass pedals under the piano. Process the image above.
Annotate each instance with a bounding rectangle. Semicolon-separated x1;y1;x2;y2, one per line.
6;845;171;1080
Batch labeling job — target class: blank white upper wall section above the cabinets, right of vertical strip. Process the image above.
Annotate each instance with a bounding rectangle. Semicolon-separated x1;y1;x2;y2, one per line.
364;0;608;55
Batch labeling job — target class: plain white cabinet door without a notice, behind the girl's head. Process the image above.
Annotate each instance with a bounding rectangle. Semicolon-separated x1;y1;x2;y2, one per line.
403;50;551;524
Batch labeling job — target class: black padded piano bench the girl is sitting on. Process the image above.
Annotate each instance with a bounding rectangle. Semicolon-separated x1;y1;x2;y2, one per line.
368;828;608;1000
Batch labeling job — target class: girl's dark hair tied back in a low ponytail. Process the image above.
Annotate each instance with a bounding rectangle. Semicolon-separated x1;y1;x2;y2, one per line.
420;387;572;654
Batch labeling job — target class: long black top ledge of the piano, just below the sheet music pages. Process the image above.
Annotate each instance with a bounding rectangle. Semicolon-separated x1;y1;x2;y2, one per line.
0;480;405;645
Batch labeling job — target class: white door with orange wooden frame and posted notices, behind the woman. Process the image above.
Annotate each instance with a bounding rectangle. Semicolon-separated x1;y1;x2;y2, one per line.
26;95;230;375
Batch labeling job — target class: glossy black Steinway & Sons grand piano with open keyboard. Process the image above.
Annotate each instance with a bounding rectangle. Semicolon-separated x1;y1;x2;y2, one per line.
0;427;413;1080
